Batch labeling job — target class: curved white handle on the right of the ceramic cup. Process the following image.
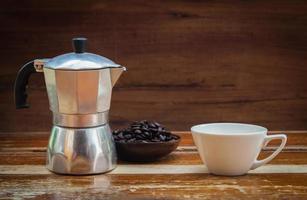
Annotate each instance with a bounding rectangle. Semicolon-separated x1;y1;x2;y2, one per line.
251;134;287;169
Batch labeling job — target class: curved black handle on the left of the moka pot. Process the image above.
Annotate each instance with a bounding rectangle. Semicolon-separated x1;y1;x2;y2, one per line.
14;60;36;109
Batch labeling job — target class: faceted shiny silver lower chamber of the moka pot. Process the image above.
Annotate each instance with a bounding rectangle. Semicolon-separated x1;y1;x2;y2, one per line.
46;124;117;175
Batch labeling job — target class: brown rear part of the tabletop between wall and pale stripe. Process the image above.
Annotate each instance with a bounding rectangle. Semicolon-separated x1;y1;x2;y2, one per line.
0;131;307;165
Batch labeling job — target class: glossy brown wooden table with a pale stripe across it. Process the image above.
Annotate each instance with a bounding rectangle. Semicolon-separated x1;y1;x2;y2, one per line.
0;131;307;200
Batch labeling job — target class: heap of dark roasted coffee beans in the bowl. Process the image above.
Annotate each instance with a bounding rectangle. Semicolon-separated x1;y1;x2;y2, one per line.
113;120;179;143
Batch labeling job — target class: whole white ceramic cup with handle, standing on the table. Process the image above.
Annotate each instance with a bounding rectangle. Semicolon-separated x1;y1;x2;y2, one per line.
191;123;287;176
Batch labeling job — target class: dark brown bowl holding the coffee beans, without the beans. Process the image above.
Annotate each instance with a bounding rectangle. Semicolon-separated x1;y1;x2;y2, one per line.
115;134;180;162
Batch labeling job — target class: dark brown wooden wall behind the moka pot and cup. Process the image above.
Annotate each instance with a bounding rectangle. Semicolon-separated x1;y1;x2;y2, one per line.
0;0;307;131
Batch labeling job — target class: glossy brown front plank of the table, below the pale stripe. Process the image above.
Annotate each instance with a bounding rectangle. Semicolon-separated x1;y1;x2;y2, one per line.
0;174;307;199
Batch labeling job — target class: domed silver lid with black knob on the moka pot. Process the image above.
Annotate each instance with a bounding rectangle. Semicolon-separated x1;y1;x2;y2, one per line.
45;38;121;70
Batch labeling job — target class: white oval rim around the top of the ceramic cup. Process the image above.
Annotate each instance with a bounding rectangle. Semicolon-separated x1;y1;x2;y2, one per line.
191;122;268;136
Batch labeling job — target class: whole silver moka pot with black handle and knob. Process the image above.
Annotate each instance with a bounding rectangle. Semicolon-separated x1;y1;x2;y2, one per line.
14;38;126;175
